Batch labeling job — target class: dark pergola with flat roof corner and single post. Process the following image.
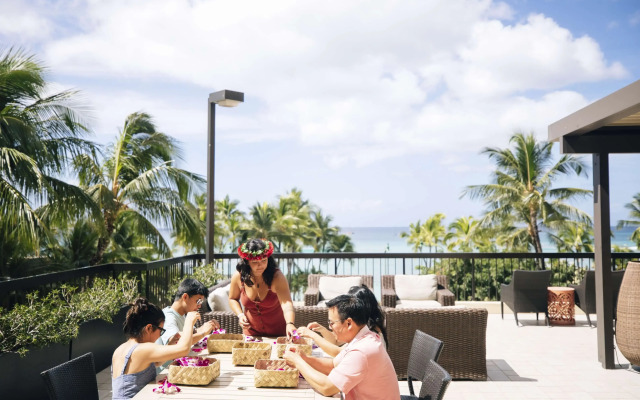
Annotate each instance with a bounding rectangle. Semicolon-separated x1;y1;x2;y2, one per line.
549;80;640;369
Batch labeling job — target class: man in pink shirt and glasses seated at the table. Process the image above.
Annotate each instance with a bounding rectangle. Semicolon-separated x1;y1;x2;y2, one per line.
284;294;400;400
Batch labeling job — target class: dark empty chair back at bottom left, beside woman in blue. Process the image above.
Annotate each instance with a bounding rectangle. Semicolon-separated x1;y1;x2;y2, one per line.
40;353;99;400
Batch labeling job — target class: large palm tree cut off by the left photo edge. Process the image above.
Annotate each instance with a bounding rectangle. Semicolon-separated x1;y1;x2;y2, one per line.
0;49;95;275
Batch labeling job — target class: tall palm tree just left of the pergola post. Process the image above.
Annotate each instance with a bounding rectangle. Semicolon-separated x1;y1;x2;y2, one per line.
462;133;591;253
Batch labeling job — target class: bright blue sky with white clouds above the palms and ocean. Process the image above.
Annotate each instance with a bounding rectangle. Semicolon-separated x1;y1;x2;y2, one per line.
0;0;640;227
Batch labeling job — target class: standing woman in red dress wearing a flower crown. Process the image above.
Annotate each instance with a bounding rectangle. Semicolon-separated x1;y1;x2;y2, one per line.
229;239;295;337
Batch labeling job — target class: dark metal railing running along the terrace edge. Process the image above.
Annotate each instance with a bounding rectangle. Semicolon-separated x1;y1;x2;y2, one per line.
0;253;640;308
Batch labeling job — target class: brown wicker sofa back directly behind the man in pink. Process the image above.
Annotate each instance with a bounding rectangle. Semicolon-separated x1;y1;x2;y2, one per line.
384;307;489;381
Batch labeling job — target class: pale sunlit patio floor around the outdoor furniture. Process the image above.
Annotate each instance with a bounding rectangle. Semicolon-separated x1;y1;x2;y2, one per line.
98;310;640;400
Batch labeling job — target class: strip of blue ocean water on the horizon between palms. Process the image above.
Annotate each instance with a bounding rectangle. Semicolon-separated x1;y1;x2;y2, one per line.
341;226;637;253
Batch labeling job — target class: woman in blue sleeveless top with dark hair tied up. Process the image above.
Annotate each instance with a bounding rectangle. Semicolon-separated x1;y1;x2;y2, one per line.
111;297;200;400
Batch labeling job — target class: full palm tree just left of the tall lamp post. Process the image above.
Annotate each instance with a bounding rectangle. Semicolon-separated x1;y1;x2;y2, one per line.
69;112;204;265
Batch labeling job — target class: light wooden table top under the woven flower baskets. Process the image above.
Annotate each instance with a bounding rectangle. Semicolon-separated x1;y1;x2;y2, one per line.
133;338;340;400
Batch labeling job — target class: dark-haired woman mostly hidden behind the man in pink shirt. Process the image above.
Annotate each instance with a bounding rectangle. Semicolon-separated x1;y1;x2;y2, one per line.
298;285;387;357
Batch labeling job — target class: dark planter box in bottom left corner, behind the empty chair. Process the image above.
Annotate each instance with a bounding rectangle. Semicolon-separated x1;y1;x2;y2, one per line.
0;343;69;400
